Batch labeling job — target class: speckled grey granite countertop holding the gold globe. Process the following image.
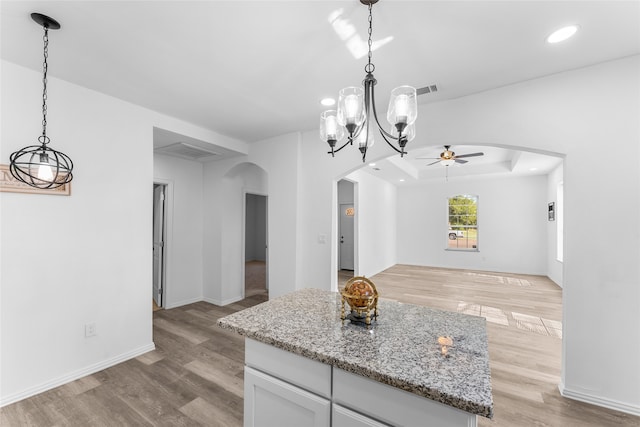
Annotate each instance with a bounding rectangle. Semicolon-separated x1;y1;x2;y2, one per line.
217;289;493;418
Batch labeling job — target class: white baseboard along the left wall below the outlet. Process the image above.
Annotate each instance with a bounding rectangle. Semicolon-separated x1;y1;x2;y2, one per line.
0;342;156;408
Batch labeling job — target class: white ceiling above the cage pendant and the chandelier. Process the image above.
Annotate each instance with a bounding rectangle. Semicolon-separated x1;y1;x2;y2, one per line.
0;0;640;179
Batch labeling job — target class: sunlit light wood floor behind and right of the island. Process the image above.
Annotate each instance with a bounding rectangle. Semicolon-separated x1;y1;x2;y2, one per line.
371;265;640;427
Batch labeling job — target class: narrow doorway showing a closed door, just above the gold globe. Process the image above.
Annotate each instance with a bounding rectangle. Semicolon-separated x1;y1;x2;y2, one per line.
338;179;356;288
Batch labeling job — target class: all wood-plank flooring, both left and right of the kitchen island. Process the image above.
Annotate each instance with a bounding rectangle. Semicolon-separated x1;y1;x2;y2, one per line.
0;265;640;427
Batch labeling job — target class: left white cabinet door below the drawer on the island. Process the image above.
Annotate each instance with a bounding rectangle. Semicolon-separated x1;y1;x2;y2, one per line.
244;366;331;427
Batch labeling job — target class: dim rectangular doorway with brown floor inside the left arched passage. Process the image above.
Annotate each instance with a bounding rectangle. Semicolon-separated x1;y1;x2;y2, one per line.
244;193;269;298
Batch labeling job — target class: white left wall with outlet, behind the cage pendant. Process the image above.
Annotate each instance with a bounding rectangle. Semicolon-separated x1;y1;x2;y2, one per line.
0;61;247;405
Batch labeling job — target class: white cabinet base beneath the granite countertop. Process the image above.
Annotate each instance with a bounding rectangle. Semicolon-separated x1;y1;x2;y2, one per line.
244;339;477;427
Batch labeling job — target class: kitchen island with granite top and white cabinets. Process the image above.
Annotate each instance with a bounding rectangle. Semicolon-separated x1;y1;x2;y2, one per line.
218;289;493;427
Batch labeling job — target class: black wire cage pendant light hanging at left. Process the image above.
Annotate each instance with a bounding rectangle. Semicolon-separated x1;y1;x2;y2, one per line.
9;13;73;189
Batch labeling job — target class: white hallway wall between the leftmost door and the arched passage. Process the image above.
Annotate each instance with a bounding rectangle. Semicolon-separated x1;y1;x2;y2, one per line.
153;154;203;308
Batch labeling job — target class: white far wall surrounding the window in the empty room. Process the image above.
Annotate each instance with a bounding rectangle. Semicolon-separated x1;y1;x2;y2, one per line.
397;175;547;275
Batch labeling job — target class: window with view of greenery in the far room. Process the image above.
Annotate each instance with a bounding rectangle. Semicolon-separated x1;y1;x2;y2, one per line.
447;195;478;251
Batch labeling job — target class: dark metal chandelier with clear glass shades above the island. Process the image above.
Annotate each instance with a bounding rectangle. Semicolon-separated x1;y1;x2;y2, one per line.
320;0;418;162
